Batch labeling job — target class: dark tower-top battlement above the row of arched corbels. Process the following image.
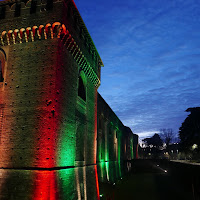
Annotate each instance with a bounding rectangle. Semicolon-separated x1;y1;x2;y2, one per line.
0;0;103;66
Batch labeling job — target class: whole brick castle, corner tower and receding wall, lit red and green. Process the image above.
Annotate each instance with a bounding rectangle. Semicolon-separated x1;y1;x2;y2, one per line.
0;0;138;200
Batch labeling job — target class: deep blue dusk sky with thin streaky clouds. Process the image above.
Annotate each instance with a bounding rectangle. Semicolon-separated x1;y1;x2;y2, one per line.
75;0;200;137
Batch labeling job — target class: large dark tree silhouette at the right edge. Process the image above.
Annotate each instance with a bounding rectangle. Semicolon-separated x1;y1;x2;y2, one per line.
179;107;200;153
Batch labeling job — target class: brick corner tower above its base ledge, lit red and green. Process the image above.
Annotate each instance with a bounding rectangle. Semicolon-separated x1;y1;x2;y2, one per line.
0;0;102;168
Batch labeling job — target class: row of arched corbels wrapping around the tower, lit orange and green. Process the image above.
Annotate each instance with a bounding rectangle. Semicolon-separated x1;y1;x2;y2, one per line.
0;22;100;88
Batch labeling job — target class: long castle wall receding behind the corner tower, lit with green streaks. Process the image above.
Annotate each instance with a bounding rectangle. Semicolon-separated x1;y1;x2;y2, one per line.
97;94;138;162
